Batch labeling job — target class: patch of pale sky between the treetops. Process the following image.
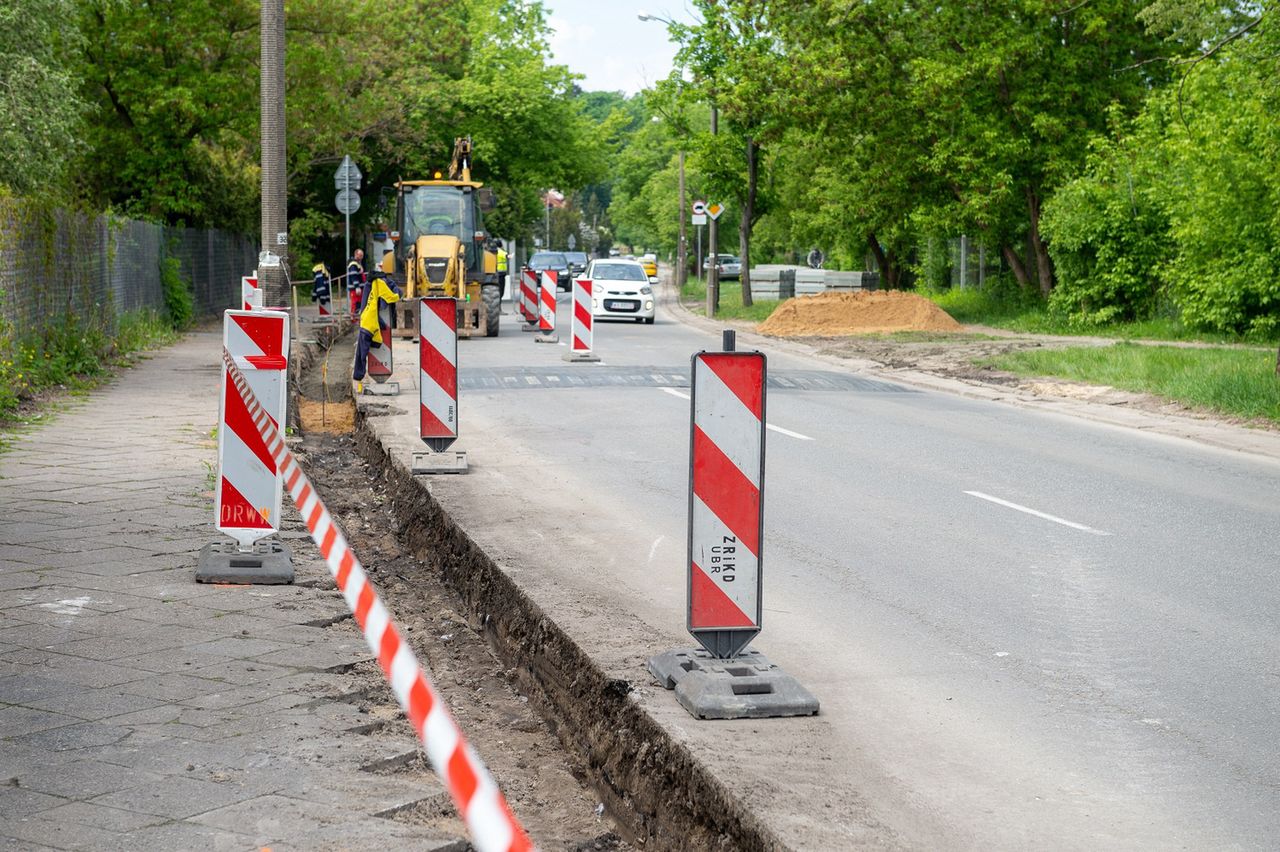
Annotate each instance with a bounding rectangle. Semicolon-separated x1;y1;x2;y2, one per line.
544;0;692;95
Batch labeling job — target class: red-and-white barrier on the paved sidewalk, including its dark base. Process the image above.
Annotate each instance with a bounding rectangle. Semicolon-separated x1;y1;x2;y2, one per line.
196;310;293;583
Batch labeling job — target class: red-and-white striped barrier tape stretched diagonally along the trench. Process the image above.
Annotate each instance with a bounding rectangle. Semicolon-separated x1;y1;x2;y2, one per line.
223;349;534;852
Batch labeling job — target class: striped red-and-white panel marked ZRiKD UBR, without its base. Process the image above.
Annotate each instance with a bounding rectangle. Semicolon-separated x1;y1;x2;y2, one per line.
687;352;765;656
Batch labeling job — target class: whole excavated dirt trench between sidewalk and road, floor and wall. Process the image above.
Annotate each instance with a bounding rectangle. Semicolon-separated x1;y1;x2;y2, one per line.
296;330;782;851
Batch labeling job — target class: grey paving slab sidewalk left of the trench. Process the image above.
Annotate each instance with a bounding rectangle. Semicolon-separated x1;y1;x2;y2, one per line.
0;331;460;849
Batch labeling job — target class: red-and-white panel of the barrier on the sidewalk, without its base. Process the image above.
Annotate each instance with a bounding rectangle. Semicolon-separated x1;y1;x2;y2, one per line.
214;310;289;548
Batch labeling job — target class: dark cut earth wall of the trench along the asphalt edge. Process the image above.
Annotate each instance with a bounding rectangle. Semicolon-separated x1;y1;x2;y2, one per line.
356;399;787;852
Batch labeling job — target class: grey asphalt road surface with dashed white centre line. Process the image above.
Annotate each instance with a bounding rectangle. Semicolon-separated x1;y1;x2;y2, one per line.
432;286;1280;849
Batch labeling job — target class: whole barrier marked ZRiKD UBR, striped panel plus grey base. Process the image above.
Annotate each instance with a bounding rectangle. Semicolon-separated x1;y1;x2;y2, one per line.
649;331;818;719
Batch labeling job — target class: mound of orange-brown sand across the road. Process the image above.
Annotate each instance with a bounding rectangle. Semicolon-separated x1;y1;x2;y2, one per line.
755;290;963;338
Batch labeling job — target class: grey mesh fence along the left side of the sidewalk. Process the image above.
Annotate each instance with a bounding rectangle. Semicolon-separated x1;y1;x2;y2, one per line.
0;198;257;339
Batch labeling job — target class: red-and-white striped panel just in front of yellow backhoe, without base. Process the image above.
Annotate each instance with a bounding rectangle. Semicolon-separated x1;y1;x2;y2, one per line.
417;297;458;453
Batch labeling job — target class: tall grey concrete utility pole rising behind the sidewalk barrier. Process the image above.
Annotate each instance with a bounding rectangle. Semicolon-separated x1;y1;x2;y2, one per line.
259;0;289;306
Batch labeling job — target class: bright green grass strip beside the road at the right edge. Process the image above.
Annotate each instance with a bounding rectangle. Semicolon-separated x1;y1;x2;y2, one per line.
980;343;1280;425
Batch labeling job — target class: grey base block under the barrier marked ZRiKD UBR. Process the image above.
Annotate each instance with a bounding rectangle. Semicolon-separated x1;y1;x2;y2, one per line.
649;649;818;719
